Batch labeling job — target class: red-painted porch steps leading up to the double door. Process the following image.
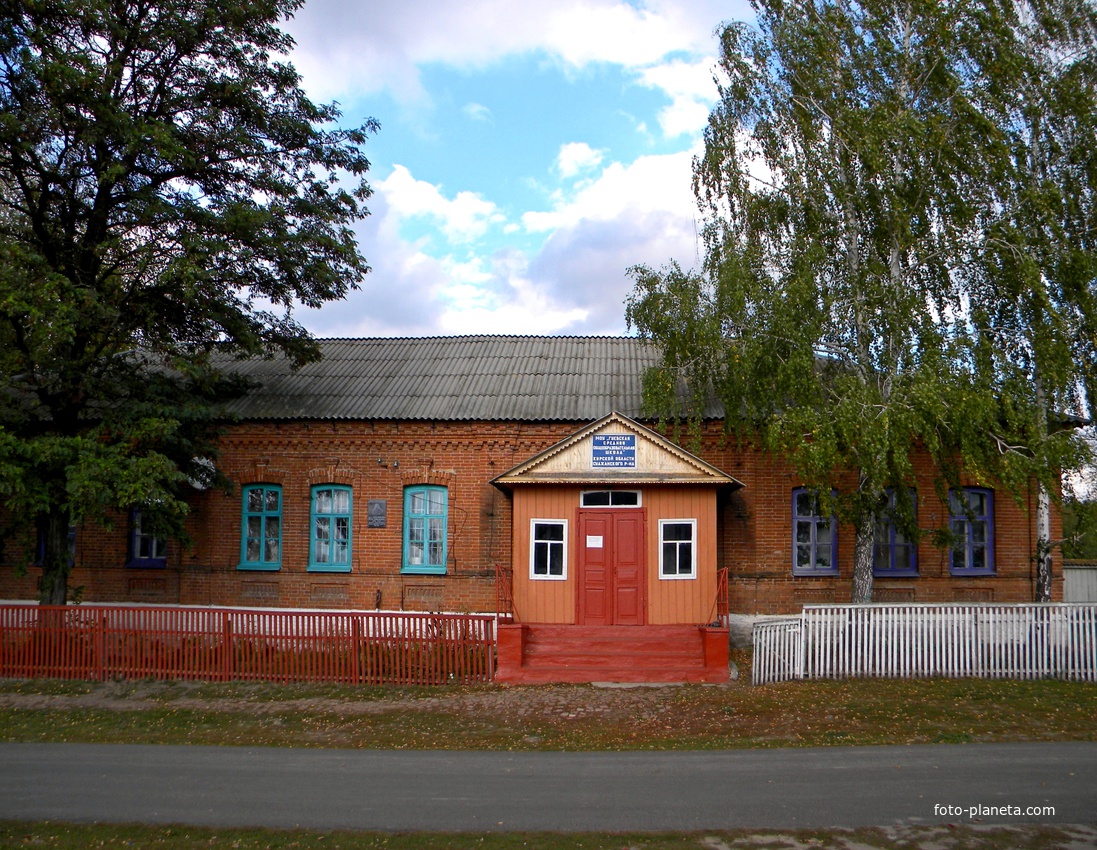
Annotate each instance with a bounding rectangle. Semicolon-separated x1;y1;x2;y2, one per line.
495;624;728;684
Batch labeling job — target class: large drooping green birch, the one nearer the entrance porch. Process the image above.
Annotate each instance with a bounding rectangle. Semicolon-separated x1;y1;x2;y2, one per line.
627;0;1097;602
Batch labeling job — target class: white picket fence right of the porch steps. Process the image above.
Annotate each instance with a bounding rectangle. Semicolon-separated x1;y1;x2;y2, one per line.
753;603;1097;684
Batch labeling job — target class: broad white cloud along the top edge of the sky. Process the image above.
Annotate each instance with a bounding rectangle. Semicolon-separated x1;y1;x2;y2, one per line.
286;0;753;102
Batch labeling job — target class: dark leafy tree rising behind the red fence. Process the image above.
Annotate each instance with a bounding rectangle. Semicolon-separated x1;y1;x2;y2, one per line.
0;0;375;604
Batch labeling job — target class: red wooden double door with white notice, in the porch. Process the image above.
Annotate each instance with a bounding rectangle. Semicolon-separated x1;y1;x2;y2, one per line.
577;509;646;625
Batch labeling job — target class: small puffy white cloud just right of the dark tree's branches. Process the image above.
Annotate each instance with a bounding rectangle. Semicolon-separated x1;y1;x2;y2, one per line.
373;166;504;242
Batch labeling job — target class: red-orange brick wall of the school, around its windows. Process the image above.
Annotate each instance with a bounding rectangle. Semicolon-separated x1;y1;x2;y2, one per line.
0;421;1062;613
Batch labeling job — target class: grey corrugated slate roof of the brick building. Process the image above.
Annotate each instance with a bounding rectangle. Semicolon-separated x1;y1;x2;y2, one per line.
220;336;719;421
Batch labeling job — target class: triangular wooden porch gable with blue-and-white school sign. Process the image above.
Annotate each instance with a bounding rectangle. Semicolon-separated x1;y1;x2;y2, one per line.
493;412;742;487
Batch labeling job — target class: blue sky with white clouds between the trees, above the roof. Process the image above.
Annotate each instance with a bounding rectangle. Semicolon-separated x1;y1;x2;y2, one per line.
278;0;751;337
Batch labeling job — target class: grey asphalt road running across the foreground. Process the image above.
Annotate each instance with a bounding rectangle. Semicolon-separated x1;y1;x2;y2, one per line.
0;743;1097;831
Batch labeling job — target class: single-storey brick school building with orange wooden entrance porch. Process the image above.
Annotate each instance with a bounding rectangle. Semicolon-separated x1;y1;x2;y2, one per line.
0;337;1062;623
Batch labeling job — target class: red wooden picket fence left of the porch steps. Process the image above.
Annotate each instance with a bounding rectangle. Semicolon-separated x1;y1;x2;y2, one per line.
0;604;495;684
